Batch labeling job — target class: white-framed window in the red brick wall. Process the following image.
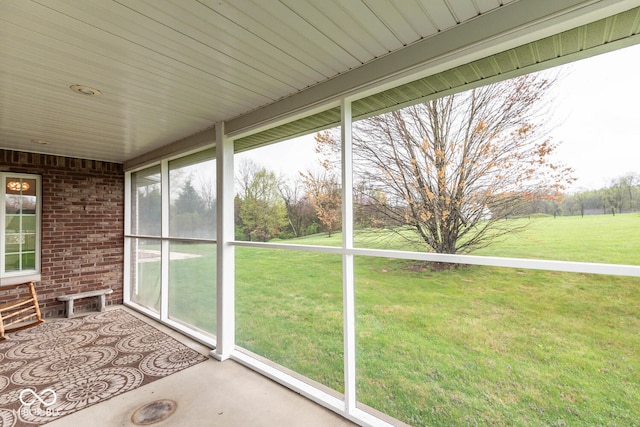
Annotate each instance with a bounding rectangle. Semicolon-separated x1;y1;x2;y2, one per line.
0;172;42;285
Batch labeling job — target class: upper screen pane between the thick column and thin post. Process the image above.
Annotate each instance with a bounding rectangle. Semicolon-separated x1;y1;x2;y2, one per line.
234;133;342;246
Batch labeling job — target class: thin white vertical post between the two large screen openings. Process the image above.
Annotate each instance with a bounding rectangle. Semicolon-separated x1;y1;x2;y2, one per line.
340;99;357;414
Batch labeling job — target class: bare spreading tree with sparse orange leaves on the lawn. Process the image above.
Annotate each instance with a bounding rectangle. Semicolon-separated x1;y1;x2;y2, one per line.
316;74;572;253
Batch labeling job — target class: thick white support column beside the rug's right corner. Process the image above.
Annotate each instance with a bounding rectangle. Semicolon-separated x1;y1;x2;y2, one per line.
211;122;235;361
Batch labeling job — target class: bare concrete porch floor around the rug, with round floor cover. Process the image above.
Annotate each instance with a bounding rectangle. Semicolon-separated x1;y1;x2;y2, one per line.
42;306;356;427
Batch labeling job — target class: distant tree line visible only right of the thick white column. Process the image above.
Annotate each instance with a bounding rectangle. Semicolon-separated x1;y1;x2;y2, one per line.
235;155;640;241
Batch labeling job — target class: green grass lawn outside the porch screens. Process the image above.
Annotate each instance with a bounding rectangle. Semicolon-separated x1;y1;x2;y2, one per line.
138;214;640;426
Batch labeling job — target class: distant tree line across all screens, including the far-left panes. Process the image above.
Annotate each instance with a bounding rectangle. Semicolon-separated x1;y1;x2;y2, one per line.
138;164;640;247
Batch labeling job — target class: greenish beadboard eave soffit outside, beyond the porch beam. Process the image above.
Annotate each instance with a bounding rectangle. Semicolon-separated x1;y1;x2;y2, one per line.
235;7;640;152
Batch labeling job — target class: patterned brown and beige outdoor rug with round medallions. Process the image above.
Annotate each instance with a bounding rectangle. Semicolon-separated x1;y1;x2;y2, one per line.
0;309;207;427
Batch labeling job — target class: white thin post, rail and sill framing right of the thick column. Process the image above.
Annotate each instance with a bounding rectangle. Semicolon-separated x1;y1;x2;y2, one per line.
223;98;640;427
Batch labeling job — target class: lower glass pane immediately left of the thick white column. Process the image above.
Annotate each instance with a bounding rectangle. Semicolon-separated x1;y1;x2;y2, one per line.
169;242;216;335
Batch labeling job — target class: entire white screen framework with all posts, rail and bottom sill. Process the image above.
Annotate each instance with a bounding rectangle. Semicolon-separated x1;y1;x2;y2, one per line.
124;106;640;427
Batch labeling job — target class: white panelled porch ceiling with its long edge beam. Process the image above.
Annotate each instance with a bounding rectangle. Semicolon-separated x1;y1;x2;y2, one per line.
0;0;640;163
